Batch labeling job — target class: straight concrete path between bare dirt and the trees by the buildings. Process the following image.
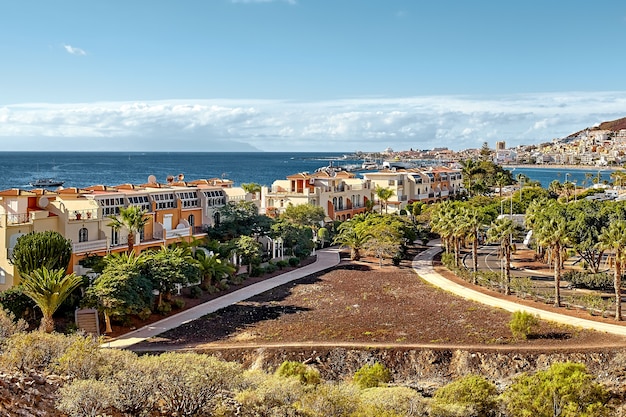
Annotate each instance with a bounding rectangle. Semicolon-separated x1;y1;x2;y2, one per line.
103;248;339;349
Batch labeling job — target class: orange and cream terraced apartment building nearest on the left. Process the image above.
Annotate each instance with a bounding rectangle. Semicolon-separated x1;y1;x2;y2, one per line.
0;179;240;291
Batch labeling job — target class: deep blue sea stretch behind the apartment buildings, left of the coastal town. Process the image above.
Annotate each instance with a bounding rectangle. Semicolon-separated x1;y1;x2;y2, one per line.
0;152;352;190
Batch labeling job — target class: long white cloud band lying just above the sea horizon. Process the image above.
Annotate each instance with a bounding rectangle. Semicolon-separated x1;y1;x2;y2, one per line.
0;92;626;152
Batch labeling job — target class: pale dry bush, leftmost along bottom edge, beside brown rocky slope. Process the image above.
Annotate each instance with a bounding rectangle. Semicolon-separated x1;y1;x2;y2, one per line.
57;380;113;417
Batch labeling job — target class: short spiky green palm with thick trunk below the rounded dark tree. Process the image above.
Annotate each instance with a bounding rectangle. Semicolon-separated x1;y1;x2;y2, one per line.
22;267;83;333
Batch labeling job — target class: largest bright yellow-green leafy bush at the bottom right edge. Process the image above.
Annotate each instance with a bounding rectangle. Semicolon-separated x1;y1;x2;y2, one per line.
502;362;613;417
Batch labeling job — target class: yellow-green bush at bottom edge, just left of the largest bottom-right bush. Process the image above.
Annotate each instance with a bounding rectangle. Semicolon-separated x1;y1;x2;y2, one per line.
430;375;497;417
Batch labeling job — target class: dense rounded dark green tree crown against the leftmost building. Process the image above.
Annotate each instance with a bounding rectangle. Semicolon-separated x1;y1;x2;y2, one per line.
11;231;72;275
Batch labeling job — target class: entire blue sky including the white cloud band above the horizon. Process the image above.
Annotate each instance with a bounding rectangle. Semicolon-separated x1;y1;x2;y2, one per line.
0;0;626;152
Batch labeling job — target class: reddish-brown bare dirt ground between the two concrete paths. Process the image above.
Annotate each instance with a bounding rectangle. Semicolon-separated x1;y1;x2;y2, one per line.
136;247;626;350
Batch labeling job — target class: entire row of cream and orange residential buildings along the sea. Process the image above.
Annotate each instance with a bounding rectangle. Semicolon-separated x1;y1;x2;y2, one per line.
0;164;462;291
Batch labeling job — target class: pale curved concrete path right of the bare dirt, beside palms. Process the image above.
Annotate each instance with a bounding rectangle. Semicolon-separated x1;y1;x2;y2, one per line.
413;246;626;336
